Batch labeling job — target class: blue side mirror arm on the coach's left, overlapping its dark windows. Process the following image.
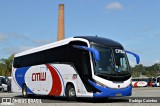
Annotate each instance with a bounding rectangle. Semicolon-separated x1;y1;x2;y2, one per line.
73;45;100;61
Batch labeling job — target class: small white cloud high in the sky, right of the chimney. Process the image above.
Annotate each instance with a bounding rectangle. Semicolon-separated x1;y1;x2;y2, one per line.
106;2;123;10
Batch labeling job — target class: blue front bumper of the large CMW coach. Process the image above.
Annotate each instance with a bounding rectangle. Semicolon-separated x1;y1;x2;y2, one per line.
88;80;132;98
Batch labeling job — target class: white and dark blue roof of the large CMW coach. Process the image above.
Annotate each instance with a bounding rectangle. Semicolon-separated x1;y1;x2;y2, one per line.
15;36;122;57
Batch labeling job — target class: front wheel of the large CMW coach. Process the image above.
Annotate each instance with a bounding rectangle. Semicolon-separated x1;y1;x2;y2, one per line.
66;84;76;101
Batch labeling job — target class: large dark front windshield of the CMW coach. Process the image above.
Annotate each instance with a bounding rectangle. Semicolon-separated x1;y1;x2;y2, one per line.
92;44;130;76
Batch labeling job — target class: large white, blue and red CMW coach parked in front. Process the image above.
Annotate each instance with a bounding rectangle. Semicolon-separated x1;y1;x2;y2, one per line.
12;36;139;100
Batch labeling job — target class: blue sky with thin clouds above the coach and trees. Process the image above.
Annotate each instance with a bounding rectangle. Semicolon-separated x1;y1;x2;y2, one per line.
0;0;160;66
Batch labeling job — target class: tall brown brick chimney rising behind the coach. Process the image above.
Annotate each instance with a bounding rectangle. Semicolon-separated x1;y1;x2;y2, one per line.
57;4;64;41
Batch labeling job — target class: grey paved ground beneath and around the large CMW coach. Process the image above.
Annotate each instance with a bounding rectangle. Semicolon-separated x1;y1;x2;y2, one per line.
0;87;160;106
